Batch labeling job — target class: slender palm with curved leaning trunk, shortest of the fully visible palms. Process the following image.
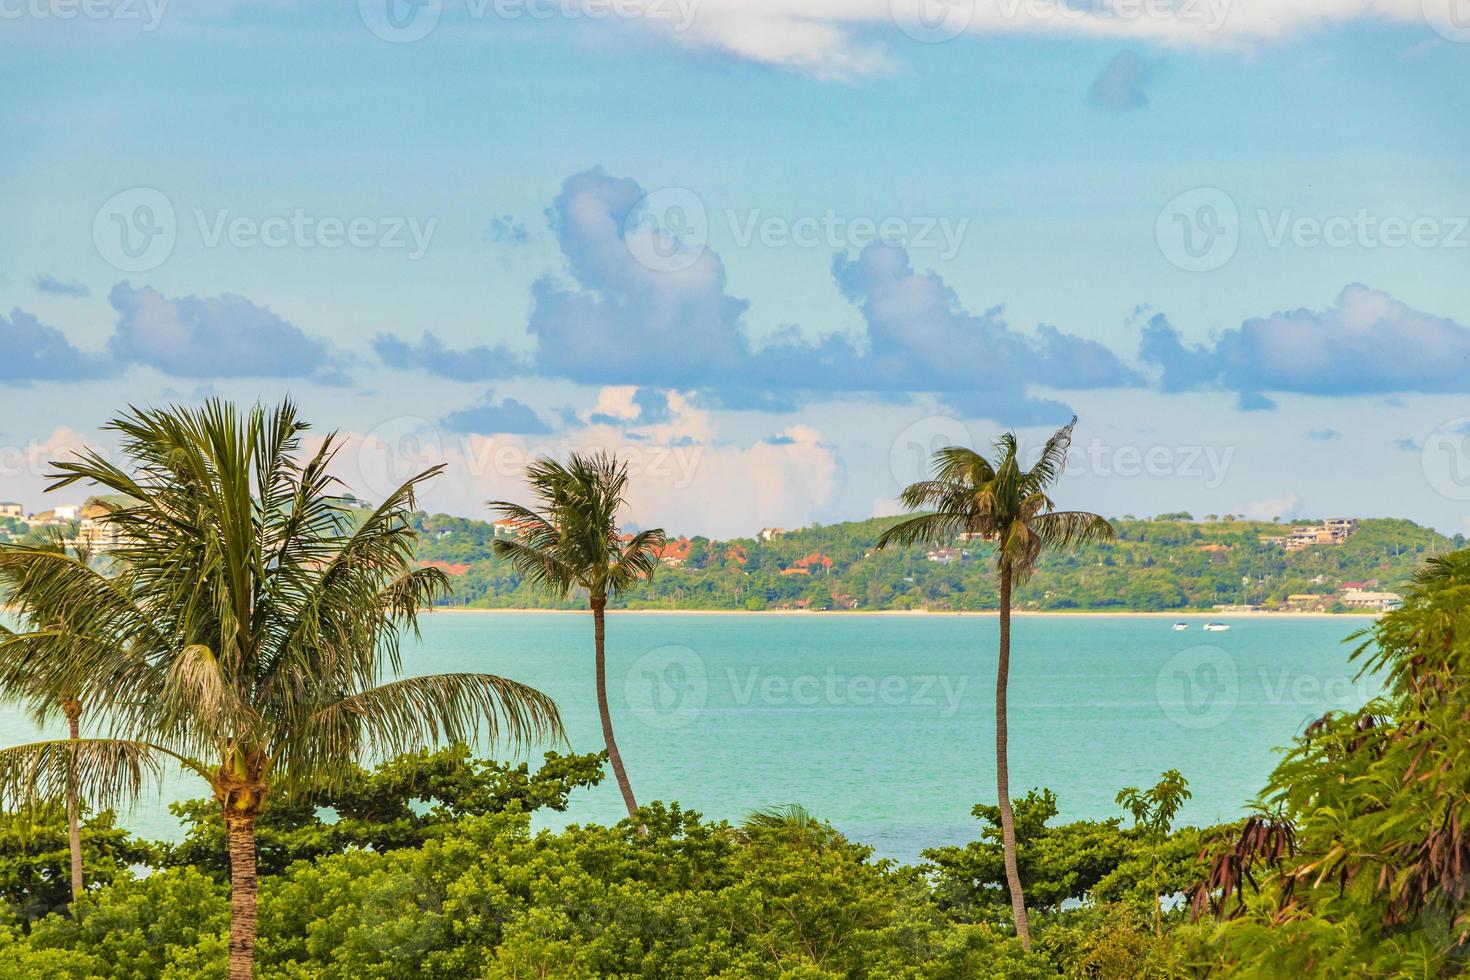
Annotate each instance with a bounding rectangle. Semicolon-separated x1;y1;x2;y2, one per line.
490;453;664;830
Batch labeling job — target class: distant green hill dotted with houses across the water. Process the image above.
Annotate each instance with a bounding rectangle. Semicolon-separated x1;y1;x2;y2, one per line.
416;514;1464;611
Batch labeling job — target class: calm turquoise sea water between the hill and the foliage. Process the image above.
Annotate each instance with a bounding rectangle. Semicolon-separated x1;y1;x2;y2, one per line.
0;613;1376;860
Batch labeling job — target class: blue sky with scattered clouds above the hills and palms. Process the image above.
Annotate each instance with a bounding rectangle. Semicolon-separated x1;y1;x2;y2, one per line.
0;0;1470;533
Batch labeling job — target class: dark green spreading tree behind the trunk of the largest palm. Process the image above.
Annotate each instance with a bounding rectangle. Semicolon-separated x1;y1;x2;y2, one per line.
160;743;607;882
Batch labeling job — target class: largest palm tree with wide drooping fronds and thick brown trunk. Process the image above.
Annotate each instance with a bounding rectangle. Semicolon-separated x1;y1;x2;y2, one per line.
0;401;562;980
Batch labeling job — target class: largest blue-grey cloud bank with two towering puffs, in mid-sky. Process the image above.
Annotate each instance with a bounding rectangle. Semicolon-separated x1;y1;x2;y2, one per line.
375;169;1139;425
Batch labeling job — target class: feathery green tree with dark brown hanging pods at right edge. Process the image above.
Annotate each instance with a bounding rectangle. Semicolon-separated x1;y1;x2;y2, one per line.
1197;551;1470;977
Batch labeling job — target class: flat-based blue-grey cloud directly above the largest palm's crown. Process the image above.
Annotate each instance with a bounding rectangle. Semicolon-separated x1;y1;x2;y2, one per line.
107;282;332;378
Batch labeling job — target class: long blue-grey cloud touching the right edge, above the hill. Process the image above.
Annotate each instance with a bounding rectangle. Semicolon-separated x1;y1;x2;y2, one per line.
1139;284;1470;408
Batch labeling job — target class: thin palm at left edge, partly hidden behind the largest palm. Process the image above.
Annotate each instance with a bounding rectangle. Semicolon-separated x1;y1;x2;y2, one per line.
0;532;102;902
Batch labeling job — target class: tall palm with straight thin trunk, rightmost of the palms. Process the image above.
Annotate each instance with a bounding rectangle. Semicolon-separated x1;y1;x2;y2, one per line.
878;416;1113;949
